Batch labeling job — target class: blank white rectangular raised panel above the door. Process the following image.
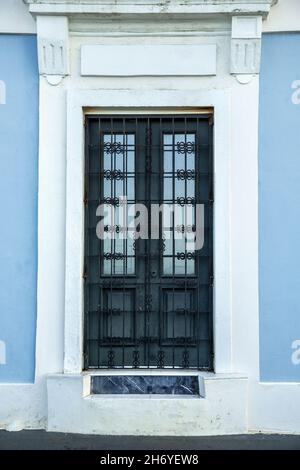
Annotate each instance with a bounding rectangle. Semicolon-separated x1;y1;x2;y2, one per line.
81;44;217;76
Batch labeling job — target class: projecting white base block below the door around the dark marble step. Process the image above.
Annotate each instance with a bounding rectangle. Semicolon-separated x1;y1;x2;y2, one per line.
47;375;247;436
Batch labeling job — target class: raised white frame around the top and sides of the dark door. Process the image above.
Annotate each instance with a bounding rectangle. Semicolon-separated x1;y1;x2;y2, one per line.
64;90;232;374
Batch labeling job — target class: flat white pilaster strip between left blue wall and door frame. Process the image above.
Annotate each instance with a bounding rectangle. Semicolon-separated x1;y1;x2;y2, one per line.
36;77;66;378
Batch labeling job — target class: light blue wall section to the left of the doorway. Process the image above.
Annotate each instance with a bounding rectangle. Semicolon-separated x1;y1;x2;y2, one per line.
0;35;38;382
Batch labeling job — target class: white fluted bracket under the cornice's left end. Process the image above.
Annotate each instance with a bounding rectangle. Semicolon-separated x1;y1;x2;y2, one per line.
37;16;69;85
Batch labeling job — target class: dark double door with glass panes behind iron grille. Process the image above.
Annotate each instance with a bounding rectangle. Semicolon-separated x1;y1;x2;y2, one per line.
84;115;213;370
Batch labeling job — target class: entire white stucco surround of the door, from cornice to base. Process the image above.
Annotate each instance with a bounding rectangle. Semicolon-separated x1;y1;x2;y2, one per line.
0;0;300;435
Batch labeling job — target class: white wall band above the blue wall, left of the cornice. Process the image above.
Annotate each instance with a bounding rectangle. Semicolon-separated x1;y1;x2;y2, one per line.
0;0;36;34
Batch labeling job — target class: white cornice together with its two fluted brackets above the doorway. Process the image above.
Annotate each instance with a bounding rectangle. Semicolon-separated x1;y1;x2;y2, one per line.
28;0;273;84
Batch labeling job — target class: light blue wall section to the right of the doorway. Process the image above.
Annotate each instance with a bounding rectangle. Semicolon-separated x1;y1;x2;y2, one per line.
259;33;300;382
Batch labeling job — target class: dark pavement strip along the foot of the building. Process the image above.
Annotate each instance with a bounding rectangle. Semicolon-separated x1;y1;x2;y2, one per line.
0;431;300;450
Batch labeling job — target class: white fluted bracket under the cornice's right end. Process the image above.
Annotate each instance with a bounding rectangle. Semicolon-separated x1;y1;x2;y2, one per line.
230;16;262;75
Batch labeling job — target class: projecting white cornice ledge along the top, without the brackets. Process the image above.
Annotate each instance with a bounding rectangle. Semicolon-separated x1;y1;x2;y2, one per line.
24;0;277;16
